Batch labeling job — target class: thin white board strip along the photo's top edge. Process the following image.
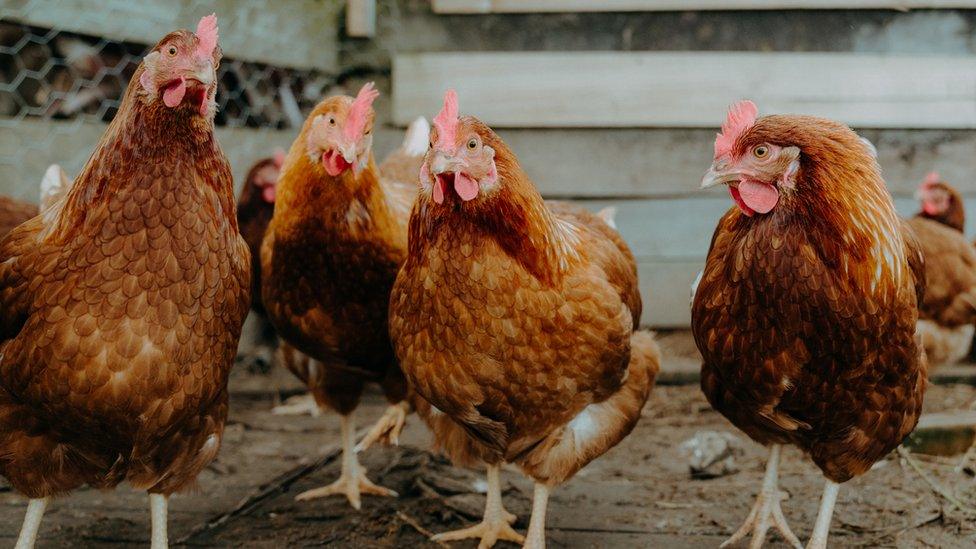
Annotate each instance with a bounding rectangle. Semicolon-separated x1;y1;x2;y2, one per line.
433;0;976;13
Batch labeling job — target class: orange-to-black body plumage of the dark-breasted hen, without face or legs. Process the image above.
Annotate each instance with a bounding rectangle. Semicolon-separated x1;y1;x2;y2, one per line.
261;97;408;414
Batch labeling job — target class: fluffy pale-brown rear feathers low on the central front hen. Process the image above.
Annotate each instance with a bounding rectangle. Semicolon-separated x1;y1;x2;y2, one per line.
518;331;661;484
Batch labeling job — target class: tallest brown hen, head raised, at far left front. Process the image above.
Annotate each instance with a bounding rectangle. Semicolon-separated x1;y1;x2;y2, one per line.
0;15;250;549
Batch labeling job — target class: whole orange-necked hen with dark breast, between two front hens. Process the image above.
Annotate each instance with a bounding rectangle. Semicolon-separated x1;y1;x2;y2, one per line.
261;83;427;509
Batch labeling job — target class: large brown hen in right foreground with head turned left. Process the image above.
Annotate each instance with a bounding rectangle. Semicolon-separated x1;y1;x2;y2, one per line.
692;101;926;549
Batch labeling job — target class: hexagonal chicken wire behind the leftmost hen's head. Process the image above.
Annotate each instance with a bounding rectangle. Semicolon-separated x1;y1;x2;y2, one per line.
0;15;334;201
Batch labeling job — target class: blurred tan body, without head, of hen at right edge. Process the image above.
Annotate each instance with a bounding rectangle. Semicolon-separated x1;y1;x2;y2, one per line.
908;216;976;364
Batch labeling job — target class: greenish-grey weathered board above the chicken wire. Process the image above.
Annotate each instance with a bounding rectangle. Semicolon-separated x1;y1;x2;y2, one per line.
2;0;342;71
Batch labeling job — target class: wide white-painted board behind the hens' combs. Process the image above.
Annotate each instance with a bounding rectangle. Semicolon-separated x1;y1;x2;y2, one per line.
393;52;976;128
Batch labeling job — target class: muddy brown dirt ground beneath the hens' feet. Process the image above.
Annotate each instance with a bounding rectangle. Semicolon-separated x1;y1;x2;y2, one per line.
0;334;976;548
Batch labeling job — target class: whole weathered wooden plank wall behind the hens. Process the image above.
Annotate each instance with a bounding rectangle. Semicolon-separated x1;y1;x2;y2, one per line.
0;0;976;327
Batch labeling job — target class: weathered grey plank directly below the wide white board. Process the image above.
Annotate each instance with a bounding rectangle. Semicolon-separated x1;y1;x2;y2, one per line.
378;124;976;198
